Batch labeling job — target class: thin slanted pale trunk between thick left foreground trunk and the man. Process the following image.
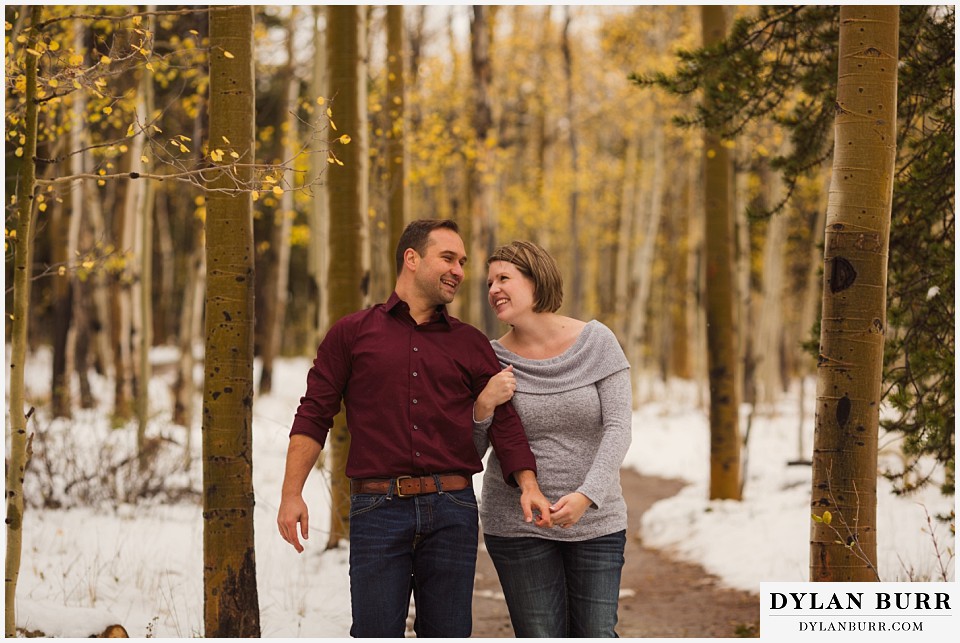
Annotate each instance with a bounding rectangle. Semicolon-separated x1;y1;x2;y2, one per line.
259;6;300;395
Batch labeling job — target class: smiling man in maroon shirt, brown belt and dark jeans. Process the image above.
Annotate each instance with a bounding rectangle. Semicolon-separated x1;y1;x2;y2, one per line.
277;219;551;637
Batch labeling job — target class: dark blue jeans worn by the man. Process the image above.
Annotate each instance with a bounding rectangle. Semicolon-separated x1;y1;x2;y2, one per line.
350;488;480;638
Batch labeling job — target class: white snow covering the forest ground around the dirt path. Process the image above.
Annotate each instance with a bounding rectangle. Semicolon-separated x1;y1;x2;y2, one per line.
8;352;954;638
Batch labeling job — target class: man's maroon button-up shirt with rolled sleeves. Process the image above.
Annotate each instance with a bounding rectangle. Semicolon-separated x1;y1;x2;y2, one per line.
290;293;536;484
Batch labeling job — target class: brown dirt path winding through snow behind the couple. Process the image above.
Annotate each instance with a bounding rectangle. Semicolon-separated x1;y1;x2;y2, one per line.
473;469;760;638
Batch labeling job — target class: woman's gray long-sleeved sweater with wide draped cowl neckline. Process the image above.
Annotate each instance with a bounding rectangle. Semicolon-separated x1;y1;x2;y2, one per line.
474;320;632;541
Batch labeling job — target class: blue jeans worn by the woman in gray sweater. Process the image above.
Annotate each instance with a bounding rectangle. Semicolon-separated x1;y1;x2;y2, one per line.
484;531;627;638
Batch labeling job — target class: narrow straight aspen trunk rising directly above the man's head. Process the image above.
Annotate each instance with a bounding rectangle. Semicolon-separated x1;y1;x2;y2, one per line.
387;5;407;262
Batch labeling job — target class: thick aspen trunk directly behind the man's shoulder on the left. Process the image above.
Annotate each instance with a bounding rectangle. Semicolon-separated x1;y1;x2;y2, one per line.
327;5;368;548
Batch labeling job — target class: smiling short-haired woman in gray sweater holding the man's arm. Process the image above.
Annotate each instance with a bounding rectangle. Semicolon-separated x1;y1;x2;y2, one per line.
474;241;631;637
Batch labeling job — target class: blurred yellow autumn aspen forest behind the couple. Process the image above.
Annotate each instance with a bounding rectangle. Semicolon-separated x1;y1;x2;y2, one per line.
5;6;955;640
